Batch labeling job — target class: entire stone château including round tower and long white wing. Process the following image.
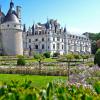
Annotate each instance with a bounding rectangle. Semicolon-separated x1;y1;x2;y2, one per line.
0;0;91;56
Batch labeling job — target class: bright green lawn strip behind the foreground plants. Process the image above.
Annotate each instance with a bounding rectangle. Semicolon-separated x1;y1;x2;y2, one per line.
0;74;66;88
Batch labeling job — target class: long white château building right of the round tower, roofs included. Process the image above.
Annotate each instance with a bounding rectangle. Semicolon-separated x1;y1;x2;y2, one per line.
23;19;91;55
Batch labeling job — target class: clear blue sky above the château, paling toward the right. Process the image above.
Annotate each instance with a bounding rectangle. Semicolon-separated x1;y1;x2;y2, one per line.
0;0;100;33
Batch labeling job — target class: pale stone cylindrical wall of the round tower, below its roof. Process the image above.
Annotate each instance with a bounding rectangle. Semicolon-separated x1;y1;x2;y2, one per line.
1;22;23;56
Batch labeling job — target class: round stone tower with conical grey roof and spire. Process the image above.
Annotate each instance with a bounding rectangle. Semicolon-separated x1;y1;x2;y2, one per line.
1;1;23;56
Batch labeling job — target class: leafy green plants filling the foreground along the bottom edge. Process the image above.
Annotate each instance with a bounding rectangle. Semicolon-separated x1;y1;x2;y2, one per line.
0;80;100;100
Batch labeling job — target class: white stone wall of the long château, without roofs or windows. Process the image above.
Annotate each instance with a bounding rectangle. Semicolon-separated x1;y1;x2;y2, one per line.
22;32;91;55
